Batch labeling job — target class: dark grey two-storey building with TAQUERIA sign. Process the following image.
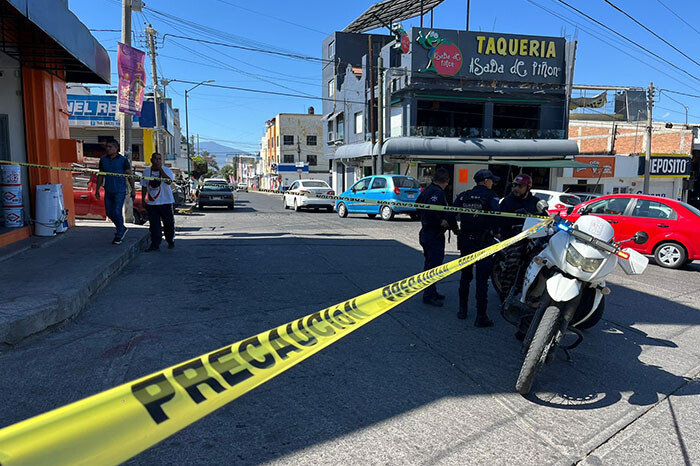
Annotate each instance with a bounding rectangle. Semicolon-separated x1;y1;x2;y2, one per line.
322;27;576;195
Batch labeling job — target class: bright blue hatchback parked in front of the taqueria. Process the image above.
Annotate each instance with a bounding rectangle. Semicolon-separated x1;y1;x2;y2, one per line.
335;175;421;220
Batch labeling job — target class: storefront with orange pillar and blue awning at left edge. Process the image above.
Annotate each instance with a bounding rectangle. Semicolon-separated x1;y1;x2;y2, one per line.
0;0;110;246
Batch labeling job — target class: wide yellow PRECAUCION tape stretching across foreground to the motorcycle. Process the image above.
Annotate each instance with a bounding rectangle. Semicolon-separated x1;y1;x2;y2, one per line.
0;221;549;466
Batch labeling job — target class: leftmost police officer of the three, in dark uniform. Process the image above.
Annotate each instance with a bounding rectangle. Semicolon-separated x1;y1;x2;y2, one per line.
416;168;457;307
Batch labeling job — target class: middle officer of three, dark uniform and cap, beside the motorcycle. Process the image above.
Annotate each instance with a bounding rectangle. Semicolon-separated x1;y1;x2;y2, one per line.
452;169;500;327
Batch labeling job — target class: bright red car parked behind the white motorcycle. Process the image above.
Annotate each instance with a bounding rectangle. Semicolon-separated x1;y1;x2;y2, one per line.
567;194;700;269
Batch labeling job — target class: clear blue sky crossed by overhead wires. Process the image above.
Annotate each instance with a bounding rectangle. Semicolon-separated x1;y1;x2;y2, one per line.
69;0;700;151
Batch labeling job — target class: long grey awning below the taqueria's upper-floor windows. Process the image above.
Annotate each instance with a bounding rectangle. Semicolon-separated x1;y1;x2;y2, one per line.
331;136;578;162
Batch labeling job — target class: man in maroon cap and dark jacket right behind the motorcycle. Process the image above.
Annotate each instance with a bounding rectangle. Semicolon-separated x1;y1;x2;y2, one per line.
500;174;542;300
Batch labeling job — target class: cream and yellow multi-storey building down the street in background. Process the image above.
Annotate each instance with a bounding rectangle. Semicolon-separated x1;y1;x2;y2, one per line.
260;107;330;190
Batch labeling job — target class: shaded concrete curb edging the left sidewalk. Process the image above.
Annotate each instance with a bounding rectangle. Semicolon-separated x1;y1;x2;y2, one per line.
0;230;149;345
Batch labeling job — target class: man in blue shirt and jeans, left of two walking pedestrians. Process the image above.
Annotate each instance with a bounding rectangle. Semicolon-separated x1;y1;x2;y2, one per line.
95;139;136;244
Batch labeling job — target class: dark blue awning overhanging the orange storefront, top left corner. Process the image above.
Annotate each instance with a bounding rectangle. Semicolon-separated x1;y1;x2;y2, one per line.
0;0;110;84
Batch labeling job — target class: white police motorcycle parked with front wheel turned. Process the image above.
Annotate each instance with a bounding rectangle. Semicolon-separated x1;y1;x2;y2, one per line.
504;215;649;395
